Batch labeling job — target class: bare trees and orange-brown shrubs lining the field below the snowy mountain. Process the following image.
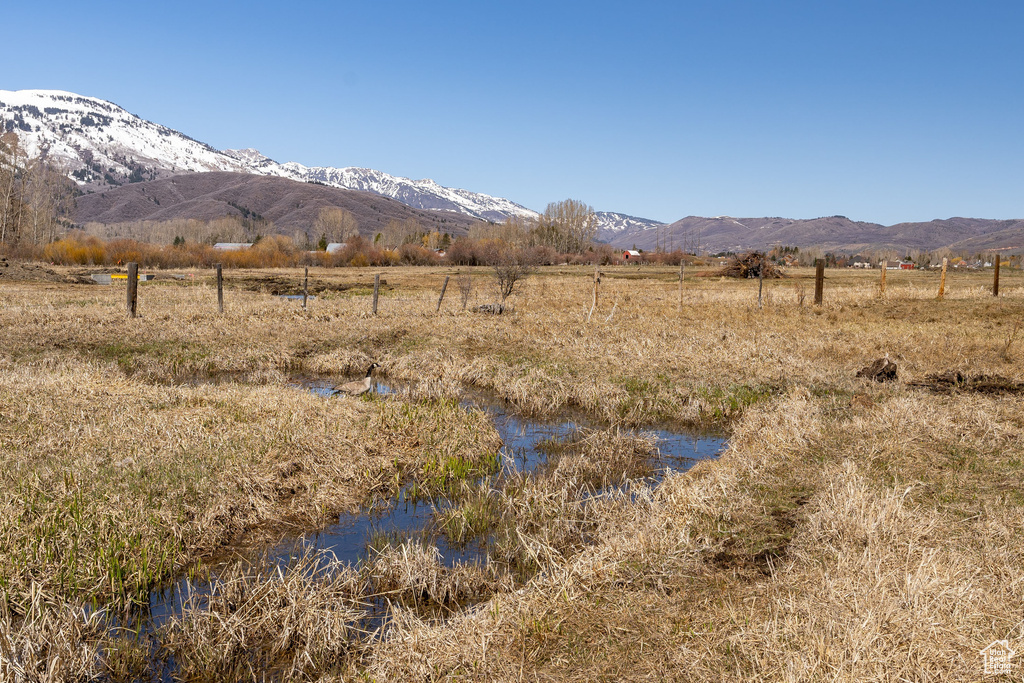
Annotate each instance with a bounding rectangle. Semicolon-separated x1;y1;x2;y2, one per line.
0;144;615;266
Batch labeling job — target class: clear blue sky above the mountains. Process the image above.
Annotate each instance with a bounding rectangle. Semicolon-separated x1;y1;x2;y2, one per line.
0;0;1024;223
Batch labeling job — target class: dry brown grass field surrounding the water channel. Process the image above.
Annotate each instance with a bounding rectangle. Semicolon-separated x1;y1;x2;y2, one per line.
0;260;1024;681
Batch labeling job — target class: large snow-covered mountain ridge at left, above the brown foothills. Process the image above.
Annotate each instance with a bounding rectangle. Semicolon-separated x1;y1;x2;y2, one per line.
0;90;537;220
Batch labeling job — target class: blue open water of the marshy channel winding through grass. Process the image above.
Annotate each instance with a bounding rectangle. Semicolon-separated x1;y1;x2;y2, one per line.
148;380;725;629
